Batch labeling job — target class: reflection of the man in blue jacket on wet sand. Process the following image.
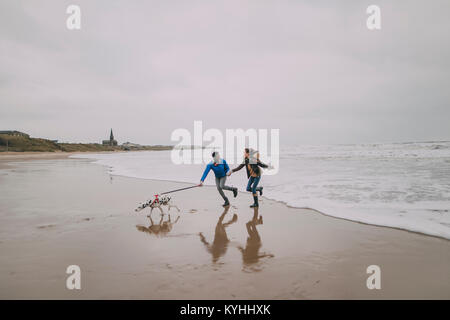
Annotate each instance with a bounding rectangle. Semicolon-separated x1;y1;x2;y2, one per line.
199;206;237;263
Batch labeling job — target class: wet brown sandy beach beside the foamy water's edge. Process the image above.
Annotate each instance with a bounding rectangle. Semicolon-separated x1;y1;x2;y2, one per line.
0;154;450;299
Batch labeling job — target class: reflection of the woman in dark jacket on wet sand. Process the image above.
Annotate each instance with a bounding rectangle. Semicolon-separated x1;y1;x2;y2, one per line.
238;207;274;268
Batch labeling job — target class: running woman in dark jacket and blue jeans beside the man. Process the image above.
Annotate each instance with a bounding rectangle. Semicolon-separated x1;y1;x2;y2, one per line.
230;148;268;208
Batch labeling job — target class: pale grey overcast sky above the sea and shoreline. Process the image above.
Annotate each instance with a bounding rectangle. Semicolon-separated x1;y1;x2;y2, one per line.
0;0;450;144
